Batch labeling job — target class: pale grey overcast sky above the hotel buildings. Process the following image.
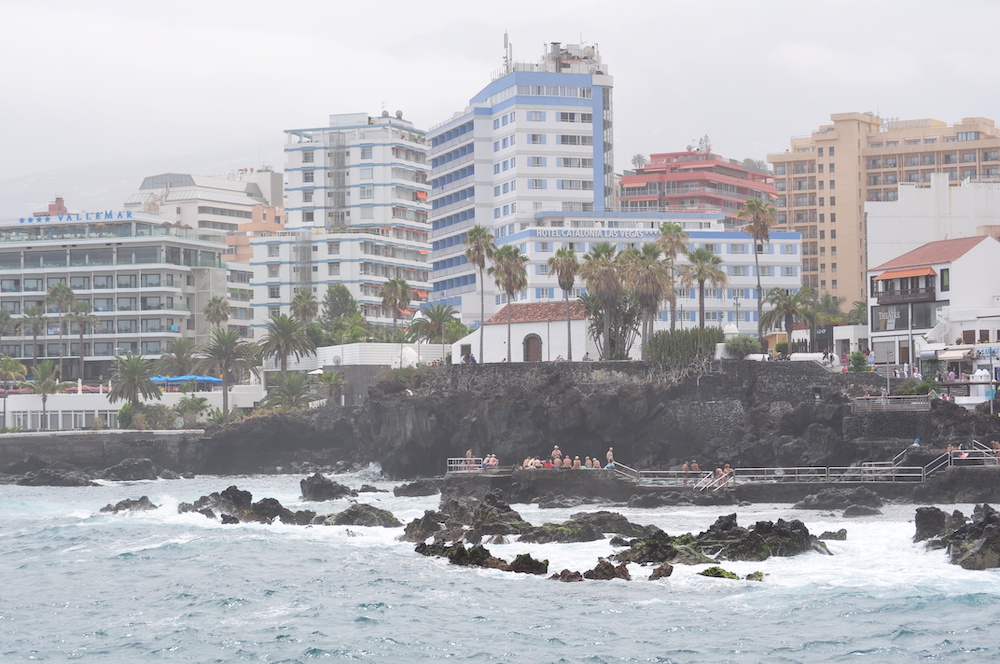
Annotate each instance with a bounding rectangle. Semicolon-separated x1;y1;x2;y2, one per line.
0;0;1000;218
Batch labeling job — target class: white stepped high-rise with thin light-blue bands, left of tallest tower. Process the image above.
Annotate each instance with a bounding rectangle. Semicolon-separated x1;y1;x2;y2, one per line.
250;112;430;325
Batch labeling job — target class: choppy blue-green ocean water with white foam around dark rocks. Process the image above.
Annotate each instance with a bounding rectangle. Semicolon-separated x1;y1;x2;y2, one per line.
0;473;1000;664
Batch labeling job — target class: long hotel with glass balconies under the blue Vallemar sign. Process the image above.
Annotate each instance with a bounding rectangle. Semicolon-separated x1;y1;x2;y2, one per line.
0;210;226;382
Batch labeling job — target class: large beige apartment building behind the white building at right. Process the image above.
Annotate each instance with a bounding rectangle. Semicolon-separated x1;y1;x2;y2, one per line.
768;113;1000;310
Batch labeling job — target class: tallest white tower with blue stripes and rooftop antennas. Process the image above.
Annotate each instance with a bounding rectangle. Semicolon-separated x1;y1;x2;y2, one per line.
428;43;614;322
